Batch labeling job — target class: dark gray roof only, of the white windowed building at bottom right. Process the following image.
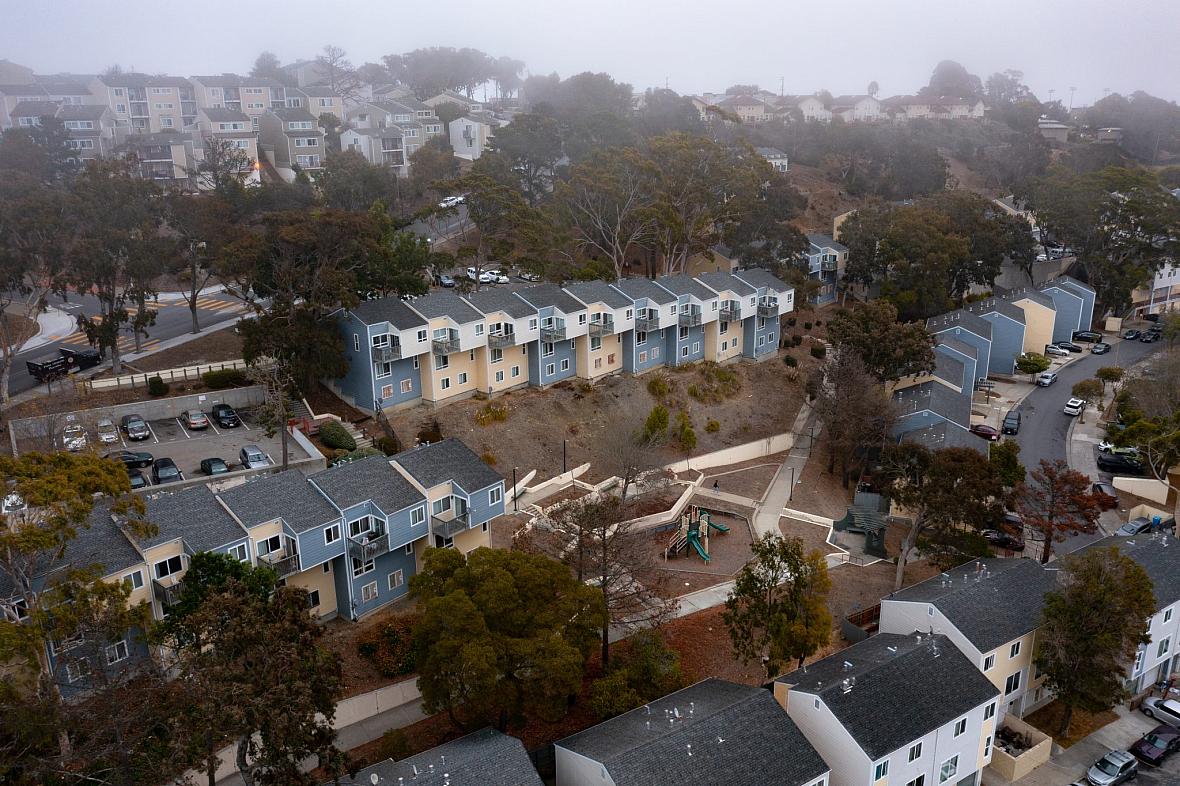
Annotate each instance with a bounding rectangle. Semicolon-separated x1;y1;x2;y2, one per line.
775;634;999;760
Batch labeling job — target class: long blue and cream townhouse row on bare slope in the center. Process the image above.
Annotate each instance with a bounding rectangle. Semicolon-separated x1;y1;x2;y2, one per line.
330;269;794;412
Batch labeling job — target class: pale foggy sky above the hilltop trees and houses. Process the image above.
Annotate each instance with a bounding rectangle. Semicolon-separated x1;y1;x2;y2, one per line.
0;0;1180;106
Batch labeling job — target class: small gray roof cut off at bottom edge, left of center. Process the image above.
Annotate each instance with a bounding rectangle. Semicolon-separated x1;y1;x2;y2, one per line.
342;728;542;786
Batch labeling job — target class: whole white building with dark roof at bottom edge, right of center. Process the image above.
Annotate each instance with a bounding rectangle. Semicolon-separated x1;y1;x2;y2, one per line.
774;631;999;786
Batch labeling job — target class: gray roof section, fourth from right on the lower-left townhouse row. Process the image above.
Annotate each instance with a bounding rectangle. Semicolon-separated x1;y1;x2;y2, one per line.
139;485;247;554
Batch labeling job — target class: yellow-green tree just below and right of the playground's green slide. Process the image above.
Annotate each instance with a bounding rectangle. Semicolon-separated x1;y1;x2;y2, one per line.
723;533;832;677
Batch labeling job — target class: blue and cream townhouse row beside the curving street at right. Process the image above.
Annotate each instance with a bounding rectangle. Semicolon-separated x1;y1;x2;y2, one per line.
892;276;1095;450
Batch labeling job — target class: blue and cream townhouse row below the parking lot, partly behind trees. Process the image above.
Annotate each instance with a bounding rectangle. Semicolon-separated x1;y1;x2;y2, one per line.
0;438;505;688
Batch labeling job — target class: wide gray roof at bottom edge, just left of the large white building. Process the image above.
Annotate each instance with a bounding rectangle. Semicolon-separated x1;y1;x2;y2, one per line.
555;679;828;786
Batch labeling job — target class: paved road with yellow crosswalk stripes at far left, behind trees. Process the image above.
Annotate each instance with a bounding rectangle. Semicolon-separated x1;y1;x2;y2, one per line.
8;294;245;395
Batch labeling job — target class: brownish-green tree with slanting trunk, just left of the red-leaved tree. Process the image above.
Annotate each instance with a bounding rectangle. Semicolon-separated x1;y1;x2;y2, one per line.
880;443;1003;589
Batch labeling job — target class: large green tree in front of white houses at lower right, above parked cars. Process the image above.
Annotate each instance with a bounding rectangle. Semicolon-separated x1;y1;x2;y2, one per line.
1036;546;1155;736
